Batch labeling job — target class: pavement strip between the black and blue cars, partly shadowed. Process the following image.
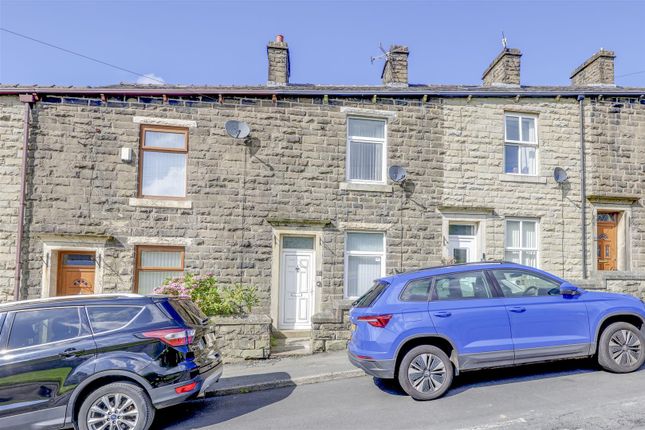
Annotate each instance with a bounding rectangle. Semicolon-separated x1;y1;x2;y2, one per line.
207;351;365;397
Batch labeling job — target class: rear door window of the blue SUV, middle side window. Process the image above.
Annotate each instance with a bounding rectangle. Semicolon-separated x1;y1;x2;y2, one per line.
432;271;493;300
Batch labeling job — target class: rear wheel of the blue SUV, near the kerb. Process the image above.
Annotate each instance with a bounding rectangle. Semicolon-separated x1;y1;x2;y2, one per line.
399;345;453;400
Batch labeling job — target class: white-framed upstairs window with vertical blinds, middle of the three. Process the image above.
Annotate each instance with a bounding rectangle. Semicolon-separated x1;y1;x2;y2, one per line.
347;118;387;183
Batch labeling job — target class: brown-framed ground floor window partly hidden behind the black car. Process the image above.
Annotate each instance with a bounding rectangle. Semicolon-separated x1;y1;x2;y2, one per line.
135;246;184;294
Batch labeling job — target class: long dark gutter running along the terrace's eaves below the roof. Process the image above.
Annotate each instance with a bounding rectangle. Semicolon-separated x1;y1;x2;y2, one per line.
0;87;645;98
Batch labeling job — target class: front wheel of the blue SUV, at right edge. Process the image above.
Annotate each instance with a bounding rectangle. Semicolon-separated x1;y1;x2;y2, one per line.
598;322;645;373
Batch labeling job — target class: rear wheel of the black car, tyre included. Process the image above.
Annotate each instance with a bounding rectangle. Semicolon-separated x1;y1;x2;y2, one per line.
78;382;155;430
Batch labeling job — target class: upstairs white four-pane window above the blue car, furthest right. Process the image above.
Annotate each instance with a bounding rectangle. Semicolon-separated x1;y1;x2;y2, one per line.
504;114;538;175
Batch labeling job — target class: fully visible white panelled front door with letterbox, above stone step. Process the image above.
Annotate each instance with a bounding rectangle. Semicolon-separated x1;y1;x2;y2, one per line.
278;249;315;329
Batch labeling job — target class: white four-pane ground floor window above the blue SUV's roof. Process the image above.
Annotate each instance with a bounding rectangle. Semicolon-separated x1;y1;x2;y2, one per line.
504;219;538;267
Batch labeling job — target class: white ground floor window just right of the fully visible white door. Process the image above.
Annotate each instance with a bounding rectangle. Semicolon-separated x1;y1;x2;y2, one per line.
345;232;385;298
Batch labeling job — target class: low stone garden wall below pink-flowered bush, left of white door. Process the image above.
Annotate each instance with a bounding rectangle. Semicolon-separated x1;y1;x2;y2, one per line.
211;315;272;363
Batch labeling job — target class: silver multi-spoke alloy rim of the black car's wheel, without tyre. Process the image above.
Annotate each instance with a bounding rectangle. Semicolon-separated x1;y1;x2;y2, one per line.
87;393;139;430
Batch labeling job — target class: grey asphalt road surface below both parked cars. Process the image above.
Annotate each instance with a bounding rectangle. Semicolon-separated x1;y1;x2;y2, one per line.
153;355;645;430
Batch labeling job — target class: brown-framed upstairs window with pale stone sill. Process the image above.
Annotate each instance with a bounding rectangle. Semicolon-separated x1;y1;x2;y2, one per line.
139;126;188;198
